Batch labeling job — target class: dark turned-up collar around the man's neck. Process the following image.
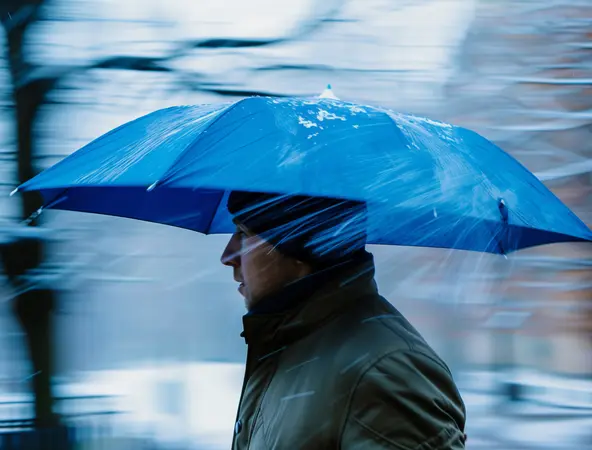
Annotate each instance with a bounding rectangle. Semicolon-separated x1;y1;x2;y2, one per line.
242;252;377;356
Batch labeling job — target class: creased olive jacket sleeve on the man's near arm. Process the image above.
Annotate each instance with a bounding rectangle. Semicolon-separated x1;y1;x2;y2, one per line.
341;350;466;450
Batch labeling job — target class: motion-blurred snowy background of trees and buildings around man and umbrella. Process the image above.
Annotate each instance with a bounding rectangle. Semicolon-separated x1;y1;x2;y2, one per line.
0;0;592;450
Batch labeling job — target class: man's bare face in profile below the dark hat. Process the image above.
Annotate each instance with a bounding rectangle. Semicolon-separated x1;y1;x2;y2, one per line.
221;224;310;309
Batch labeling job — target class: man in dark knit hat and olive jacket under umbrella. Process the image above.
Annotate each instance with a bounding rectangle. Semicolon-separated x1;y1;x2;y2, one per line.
222;192;465;450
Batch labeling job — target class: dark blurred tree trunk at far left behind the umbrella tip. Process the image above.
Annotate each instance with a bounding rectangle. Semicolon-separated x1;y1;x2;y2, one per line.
0;0;58;427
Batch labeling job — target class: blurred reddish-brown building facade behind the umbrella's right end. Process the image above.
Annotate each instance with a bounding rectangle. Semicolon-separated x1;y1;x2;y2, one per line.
448;0;592;376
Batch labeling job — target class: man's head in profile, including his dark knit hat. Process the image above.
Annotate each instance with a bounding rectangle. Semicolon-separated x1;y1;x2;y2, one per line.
222;191;366;309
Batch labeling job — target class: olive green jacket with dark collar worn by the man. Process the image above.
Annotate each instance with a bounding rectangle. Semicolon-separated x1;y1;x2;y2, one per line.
232;258;465;450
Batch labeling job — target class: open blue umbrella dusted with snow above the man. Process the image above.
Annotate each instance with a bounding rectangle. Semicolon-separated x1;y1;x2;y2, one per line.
19;89;592;254
